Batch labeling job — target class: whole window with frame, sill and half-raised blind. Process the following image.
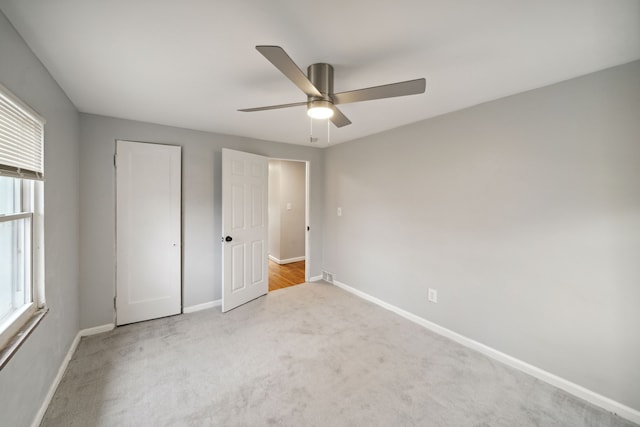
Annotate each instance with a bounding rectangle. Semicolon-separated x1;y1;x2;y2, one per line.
0;85;46;367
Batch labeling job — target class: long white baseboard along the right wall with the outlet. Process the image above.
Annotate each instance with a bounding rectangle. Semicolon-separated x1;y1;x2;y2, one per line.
333;280;640;424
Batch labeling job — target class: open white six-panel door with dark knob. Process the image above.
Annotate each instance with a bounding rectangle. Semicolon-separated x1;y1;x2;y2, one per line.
222;149;269;312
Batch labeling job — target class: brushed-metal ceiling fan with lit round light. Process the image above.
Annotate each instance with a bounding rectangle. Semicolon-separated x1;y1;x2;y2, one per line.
238;46;426;128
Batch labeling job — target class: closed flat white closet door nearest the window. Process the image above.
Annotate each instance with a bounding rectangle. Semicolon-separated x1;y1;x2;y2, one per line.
116;141;182;325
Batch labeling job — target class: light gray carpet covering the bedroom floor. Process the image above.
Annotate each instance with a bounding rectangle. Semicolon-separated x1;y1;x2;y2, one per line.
42;283;634;427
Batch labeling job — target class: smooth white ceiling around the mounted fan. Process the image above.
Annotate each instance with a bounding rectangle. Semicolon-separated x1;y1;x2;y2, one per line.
0;0;640;146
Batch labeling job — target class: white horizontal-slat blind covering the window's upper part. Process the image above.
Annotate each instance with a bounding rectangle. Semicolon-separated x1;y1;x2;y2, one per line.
0;84;45;179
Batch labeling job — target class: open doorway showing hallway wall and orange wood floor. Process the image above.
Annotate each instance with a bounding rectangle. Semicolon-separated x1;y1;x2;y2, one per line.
268;159;309;292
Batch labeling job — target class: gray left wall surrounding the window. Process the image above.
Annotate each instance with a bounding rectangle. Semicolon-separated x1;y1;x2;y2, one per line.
0;13;79;426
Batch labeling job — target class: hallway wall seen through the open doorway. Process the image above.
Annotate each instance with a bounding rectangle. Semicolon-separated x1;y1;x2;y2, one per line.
269;160;306;261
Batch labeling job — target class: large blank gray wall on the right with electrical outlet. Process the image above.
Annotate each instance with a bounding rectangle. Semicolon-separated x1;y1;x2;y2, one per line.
324;62;640;410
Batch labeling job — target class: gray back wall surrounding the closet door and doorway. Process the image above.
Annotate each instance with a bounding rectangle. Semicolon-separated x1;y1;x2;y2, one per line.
80;114;324;328
